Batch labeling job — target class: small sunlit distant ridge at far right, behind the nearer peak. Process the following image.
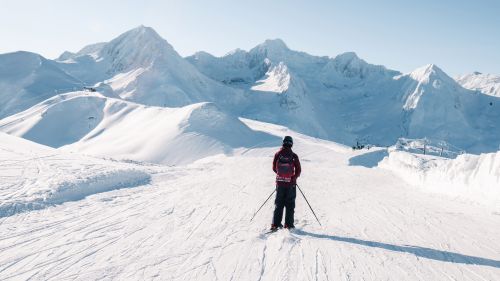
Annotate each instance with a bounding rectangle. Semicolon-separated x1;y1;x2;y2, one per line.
457;72;500;97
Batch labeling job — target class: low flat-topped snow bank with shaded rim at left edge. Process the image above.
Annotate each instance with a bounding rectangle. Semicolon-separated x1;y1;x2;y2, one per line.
0;133;150;217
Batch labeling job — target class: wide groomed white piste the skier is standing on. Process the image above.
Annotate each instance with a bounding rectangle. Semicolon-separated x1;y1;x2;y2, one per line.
0;128;500;280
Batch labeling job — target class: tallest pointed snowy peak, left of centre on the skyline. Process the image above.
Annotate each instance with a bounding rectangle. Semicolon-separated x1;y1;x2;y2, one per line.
58;26;241;106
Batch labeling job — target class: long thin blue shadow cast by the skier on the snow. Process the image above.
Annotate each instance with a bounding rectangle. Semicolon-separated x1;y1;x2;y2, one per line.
294;229;500;268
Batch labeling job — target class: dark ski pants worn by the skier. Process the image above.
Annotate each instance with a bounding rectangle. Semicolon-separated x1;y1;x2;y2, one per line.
273;185;297;226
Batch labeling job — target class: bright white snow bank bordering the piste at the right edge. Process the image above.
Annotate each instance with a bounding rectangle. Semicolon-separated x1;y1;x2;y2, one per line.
379;151;500;208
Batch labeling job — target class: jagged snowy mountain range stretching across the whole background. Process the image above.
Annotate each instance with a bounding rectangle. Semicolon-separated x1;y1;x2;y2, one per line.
0;26;500;153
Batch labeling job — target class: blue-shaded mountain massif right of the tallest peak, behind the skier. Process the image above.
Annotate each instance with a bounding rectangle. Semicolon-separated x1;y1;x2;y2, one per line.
186;39;500;152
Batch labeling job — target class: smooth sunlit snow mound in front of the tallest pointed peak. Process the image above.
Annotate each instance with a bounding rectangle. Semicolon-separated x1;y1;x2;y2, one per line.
64;100;279;165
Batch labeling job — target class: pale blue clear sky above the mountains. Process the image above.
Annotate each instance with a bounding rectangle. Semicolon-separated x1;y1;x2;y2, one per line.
0;0;500;75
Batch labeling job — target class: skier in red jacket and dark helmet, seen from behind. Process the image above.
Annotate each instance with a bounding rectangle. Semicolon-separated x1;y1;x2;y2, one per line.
271;136;301;231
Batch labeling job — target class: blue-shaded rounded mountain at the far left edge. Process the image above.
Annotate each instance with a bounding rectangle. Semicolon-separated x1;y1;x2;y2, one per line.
0;52;81;119
